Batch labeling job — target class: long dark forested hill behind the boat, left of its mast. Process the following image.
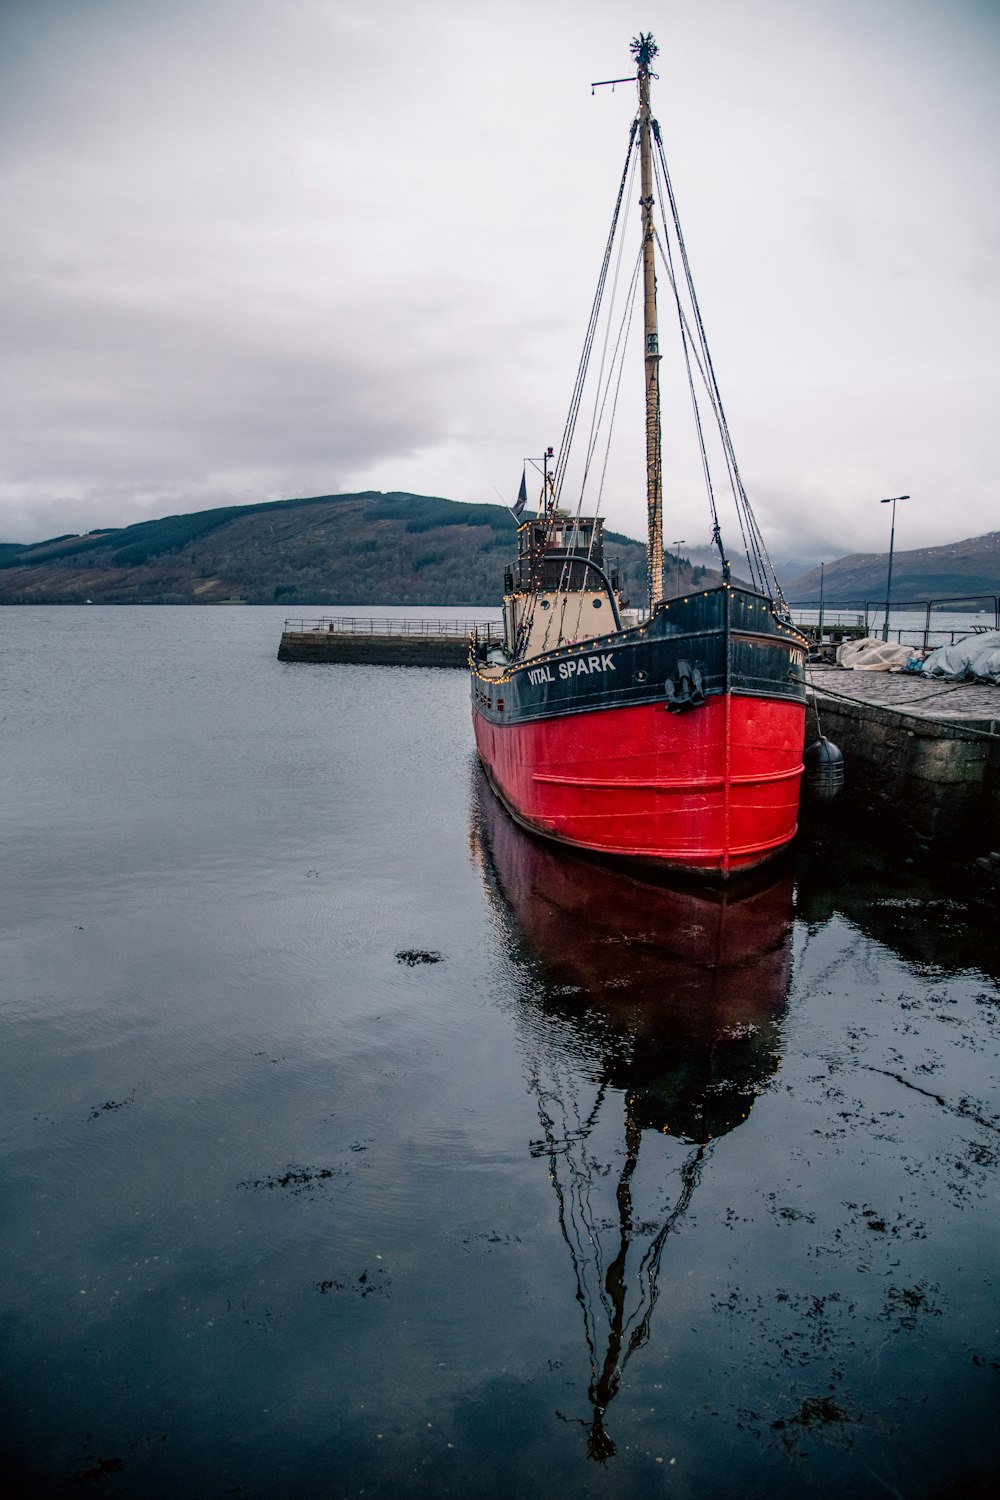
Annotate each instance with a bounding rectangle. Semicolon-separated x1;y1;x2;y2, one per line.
0;491;704;611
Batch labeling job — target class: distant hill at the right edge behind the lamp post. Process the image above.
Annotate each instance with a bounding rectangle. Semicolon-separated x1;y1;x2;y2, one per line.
784;531;1000;605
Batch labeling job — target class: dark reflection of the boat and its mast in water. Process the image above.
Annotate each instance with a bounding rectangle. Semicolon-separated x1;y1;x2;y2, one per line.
474;774;792;1461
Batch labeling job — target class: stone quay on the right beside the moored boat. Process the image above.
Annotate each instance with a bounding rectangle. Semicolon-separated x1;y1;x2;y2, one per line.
807;666;1000;857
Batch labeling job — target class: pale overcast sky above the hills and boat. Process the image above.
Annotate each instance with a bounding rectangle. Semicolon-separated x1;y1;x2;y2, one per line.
0;0;1000;558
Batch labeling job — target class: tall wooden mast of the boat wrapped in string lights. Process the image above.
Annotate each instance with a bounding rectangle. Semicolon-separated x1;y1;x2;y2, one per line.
631;32;663;612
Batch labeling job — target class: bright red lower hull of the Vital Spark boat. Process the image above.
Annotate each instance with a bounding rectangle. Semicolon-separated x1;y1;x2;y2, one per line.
472;693;805;876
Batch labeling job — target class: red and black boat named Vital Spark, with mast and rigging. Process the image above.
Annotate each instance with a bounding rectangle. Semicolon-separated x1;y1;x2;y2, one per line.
471;35;807;878
